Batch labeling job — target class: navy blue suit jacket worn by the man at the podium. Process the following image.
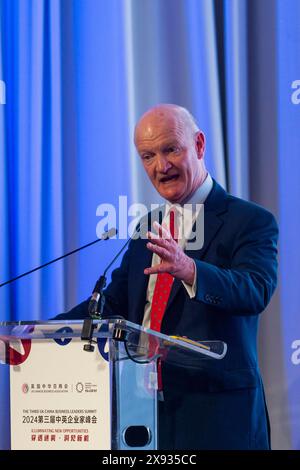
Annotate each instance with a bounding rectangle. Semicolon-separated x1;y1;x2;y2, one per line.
58;181;278;449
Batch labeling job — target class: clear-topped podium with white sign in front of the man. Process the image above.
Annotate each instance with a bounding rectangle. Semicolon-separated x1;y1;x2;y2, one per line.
0;319;227;450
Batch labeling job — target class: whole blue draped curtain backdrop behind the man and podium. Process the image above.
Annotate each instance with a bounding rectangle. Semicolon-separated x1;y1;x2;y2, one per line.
0;0;300;448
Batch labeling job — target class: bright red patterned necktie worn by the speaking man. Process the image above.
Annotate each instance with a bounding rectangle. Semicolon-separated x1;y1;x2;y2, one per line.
150;209;177;331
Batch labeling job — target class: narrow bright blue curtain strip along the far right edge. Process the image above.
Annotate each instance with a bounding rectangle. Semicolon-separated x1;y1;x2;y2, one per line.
277;0;300;449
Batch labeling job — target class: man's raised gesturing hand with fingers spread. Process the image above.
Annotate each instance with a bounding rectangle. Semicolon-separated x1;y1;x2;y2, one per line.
144;222;195;285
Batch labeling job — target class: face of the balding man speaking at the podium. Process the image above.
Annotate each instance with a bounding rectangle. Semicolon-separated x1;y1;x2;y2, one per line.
135;113;206;204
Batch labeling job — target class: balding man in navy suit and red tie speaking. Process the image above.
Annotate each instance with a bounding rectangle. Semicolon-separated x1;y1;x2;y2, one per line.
59;105;278;449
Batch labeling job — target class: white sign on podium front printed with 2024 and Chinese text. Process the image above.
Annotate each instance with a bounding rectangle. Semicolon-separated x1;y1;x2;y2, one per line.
10;327;111;450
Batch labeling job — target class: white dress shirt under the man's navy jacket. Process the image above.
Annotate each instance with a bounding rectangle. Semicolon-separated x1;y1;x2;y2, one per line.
143;173;213;328
